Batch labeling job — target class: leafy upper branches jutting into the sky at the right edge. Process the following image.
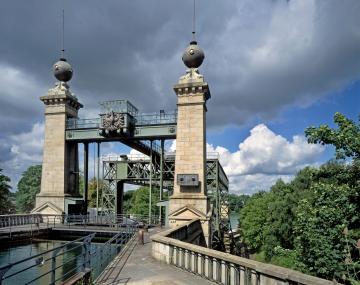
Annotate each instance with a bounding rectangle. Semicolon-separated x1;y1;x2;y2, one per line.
305;113;360;159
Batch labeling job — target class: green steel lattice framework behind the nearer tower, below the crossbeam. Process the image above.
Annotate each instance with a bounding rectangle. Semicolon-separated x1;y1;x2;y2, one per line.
102;154;232;252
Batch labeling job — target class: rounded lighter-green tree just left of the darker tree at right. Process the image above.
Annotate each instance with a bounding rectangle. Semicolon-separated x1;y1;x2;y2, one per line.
240;167;315;261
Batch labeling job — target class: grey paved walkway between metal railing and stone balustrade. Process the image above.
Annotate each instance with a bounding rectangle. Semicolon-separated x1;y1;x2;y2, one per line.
96;229;214;285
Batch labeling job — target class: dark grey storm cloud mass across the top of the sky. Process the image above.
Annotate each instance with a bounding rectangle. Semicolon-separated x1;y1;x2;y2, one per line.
0;0;360;129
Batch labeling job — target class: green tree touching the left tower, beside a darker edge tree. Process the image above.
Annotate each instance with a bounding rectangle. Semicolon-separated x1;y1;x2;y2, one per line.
16;165;41;213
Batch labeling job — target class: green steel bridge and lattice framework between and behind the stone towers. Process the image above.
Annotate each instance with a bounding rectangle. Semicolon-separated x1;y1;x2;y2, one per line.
65;100;232;251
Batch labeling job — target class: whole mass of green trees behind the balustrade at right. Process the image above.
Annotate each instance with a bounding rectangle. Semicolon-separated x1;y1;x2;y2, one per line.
240;113;360;284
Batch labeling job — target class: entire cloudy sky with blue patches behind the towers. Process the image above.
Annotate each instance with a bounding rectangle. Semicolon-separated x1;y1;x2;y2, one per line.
0;0;360;193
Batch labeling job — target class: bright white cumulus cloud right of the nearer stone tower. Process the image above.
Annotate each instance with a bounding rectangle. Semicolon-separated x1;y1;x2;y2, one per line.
170;124;324;194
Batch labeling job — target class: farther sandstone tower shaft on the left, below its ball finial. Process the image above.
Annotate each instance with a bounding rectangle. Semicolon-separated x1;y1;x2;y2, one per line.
32;82;83;214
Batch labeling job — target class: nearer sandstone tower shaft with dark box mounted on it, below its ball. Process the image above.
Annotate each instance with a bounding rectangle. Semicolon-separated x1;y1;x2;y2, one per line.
169;68;211;242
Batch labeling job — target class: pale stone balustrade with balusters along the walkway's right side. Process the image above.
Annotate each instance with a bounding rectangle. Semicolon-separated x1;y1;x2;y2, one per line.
151;220;337;285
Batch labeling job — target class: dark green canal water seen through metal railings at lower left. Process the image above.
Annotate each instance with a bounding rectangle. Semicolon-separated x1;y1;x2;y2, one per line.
0;240;117;285
